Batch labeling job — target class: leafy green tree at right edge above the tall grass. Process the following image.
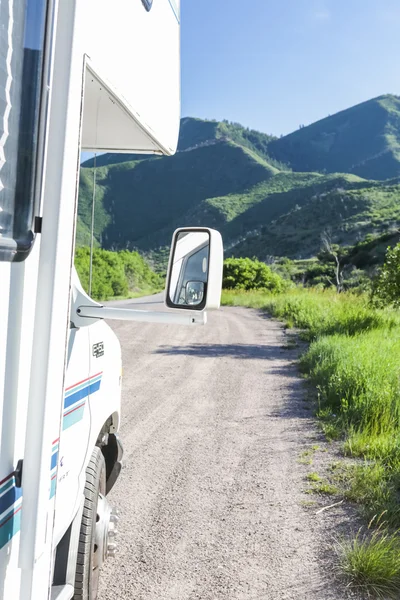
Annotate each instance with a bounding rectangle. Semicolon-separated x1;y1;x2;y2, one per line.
371;244;400;308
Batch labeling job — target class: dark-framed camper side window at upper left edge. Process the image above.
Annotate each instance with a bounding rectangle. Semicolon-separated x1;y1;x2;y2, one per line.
0;0;47;261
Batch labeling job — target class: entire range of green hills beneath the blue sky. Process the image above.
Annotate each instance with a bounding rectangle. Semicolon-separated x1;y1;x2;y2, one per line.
77;96;400;266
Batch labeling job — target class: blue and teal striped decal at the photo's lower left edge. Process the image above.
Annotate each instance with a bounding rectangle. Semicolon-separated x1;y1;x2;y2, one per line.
0;473;22;548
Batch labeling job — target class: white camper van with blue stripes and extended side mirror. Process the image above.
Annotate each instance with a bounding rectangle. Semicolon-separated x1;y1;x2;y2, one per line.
0;0;222;600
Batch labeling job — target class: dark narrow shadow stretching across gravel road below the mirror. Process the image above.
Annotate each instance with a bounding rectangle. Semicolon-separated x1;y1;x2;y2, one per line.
154;344;283;360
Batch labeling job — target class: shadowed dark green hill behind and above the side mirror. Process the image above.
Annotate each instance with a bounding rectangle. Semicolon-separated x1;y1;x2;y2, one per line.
78;141;278;250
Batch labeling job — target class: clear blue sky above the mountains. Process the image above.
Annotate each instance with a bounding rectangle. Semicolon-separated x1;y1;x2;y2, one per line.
181;0;400;135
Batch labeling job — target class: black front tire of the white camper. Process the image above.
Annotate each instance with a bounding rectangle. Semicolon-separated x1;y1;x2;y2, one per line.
74;447;106;600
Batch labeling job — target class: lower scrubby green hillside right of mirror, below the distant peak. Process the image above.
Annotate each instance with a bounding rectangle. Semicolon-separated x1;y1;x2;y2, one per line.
230;175;400;260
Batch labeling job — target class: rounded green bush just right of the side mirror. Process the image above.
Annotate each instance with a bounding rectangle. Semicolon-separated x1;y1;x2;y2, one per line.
222;258;289;293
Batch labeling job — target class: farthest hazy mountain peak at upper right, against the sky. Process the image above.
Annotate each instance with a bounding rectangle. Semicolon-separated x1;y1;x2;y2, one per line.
268;95;400;179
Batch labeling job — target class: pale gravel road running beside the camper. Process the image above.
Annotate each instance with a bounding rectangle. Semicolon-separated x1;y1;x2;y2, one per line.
100;299;345;600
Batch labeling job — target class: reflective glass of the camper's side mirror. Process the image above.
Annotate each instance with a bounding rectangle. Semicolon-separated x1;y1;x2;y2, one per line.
168;231;210;307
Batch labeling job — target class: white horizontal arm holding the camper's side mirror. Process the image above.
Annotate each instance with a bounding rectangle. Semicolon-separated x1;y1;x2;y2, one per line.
76;305;207;325
